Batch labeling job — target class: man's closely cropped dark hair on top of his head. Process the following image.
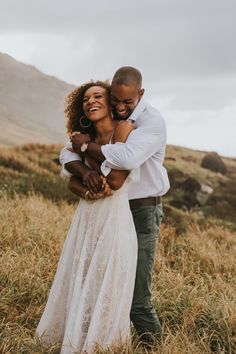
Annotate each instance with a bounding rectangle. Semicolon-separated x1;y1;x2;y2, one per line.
112;66;142;88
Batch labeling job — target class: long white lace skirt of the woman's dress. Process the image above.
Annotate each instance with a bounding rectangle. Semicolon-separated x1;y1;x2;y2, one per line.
36;171;137;354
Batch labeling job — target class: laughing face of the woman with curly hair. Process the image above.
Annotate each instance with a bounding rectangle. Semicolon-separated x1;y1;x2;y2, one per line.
83;86;111;122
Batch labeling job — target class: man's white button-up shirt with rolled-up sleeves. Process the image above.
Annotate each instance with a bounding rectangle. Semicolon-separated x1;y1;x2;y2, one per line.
60;98;170;199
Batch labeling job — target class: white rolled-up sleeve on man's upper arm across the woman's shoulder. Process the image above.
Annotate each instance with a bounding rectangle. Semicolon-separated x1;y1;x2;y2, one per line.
102;119;166;173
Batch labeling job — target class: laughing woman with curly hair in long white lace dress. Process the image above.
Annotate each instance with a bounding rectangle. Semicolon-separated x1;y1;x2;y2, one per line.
37;81;137;354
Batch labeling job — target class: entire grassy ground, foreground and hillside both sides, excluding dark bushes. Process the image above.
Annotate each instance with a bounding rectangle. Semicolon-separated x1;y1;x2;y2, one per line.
0;144;236;354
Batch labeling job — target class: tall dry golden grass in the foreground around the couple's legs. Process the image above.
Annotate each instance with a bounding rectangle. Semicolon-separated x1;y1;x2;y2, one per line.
0;195;236;354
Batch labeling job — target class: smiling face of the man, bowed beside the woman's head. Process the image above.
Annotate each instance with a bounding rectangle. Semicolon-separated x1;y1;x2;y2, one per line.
111;84;144;120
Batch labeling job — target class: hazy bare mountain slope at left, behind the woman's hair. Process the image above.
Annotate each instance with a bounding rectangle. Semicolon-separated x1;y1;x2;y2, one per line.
0;53;74;147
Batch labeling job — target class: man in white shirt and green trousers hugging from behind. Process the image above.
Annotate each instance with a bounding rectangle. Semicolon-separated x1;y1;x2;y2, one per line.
61;67;169;340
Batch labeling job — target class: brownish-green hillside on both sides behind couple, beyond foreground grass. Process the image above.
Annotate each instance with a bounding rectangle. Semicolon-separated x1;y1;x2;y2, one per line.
0;144;236;228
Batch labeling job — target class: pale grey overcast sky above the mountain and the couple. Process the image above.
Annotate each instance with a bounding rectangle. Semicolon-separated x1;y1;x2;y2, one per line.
0;0;236;157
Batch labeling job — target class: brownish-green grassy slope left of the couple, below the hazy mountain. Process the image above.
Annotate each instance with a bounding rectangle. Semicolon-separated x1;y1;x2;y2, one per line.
0;144;78;202
